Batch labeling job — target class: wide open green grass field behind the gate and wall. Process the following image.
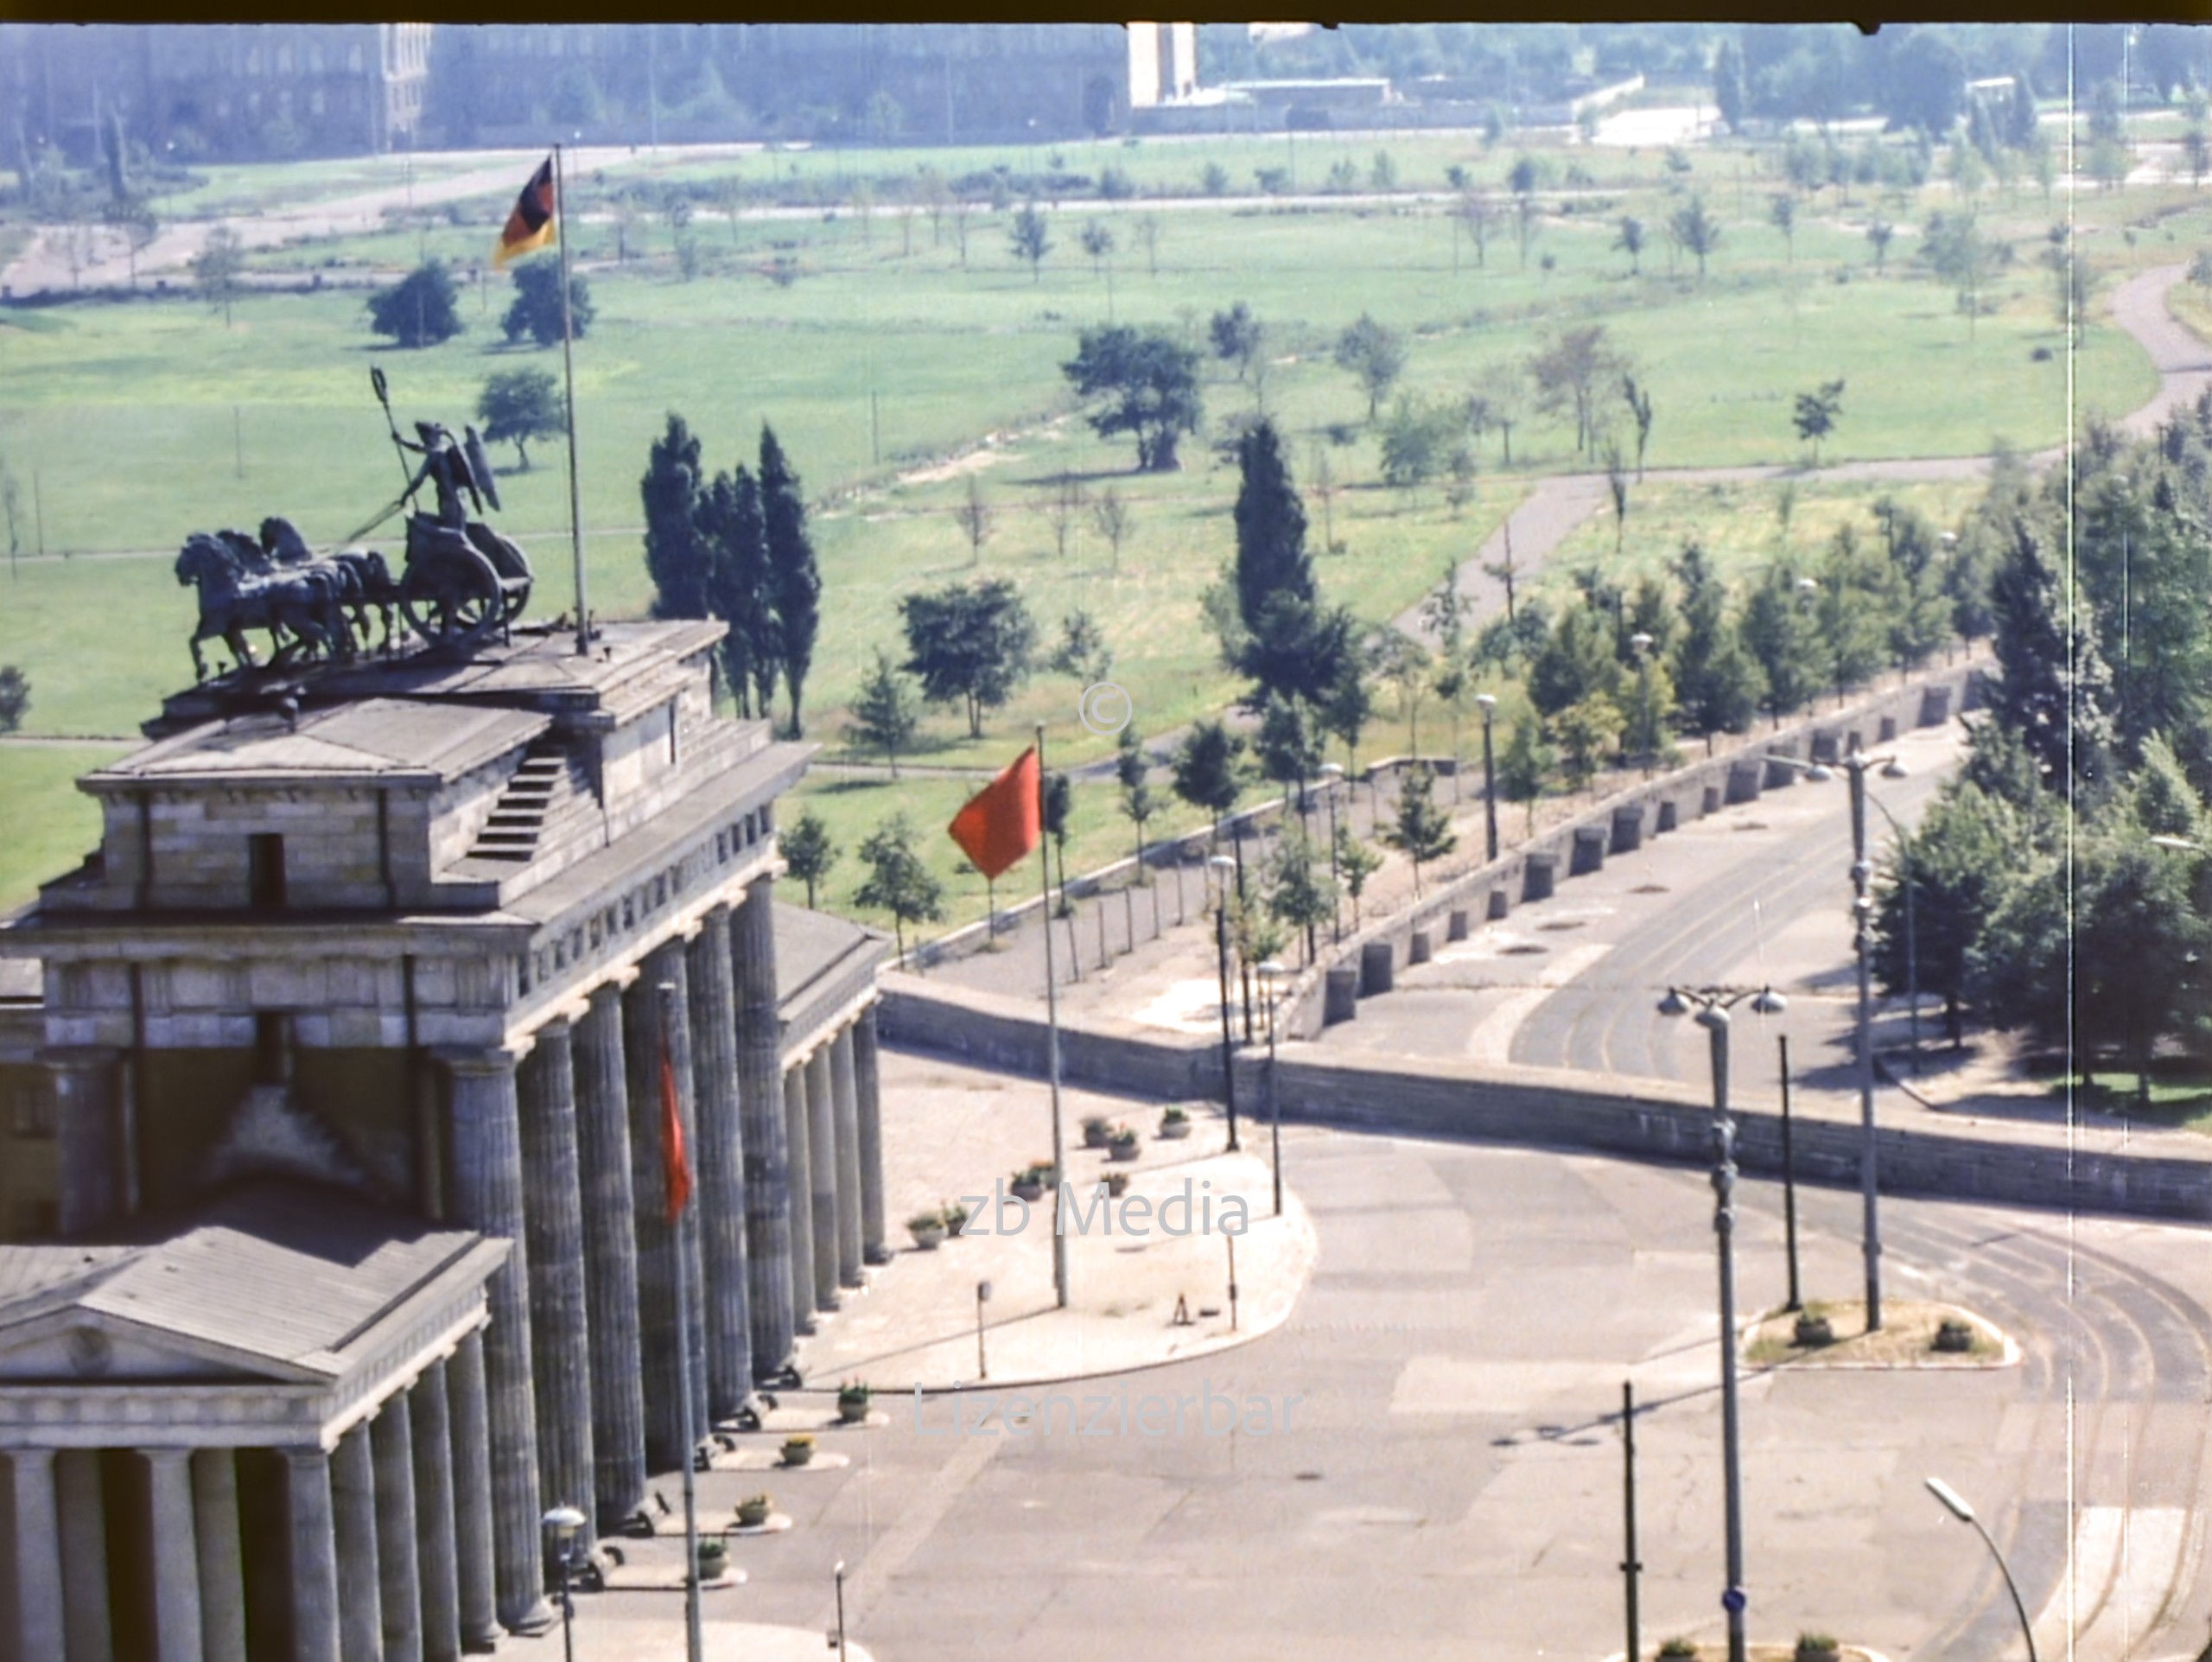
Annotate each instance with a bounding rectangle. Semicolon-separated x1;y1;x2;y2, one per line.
0;135;2212;925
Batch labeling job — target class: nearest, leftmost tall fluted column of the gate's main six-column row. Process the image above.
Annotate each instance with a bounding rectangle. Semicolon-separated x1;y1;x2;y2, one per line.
447;1049;553;1633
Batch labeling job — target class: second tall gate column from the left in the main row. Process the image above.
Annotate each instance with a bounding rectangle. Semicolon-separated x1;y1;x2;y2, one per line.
518;1018;593;1540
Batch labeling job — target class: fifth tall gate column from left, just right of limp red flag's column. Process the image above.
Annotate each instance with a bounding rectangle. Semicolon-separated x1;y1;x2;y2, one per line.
686;905;752;1418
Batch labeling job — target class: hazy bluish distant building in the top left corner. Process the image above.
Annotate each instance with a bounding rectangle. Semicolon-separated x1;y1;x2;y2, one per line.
0;22;431;166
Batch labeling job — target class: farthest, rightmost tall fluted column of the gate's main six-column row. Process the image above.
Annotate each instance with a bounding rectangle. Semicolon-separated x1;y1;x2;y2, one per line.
730;876;798;1381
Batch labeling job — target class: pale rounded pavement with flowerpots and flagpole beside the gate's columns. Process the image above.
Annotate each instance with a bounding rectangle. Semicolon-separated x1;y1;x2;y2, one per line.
777;1049;1316;1410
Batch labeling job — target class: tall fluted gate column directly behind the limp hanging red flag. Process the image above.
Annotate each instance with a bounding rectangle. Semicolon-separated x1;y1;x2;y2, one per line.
621;940;706;1472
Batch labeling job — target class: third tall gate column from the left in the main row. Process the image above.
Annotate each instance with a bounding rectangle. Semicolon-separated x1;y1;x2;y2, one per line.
573;984;646;1529
